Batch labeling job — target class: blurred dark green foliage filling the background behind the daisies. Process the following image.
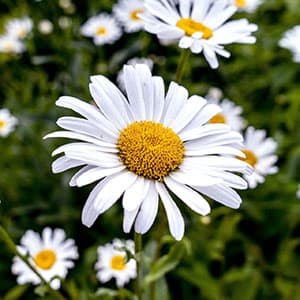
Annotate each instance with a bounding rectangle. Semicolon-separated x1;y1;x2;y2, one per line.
0;0;300;300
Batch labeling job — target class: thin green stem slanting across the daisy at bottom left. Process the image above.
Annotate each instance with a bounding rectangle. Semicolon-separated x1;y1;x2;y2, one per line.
0;225;65;300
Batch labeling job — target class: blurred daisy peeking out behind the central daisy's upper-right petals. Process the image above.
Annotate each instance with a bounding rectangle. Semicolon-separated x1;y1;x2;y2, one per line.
205;89;245;131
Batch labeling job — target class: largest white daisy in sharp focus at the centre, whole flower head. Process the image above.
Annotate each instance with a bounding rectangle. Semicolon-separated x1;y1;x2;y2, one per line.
46;65;252;240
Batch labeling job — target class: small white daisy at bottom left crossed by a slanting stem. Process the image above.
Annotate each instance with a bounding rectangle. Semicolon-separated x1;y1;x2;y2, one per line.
12;227;78;289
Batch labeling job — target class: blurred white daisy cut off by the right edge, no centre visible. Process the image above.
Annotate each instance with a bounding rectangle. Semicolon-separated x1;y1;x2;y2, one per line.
279;25;300;63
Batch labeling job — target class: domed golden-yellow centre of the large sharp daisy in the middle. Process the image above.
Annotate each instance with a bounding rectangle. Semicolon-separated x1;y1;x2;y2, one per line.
117;121;184;180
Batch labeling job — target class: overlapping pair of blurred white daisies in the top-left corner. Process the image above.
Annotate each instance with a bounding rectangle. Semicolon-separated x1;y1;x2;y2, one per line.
0;17;33;54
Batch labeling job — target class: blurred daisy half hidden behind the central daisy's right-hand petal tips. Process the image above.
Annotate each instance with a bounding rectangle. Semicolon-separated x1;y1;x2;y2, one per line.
239;126;278;189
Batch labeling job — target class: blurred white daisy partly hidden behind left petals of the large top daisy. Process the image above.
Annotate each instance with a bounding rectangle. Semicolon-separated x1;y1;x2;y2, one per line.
113;0;144;33
